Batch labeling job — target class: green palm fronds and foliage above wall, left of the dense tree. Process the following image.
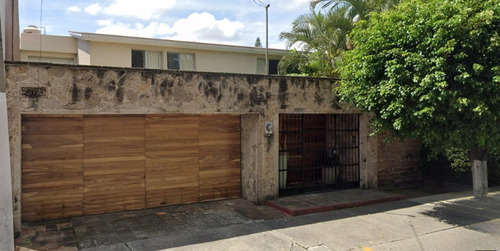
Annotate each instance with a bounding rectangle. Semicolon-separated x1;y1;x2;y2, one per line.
280;0;399;77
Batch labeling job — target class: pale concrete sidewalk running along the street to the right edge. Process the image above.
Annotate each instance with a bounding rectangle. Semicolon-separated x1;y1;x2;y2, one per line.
80;189;500;251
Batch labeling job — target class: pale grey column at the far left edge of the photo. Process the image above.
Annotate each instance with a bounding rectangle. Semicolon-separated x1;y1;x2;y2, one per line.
0;92;14;250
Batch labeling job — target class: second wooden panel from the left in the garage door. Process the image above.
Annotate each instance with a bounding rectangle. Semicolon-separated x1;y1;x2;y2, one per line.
84;115;145;214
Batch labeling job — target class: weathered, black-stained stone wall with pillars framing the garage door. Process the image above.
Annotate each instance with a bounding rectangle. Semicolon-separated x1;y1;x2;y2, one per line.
6;63;374;229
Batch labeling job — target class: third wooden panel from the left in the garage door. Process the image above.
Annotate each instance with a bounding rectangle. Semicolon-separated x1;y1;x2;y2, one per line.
146;115;199;207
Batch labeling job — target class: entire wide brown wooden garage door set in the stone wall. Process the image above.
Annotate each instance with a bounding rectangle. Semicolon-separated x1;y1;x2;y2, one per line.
22;115;241;221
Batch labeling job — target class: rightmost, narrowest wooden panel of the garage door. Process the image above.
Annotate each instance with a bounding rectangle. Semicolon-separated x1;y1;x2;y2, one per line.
199;116;241;200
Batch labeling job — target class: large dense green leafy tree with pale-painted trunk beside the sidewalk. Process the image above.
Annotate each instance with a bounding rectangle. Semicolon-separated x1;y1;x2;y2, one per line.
338;0;500;197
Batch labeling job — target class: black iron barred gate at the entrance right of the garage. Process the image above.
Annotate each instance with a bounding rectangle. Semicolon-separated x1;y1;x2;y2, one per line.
278;114;359;195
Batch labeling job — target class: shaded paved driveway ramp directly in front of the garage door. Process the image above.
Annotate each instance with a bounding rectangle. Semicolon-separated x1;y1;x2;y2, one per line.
15;199;288;251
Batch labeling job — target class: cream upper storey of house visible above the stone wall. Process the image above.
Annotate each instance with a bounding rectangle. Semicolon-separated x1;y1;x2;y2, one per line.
21;26;288;74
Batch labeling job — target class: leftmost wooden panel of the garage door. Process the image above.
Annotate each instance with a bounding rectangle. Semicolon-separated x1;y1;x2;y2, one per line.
22;115;83;221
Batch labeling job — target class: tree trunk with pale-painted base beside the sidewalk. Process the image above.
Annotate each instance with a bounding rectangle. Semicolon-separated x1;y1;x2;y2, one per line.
469;147;488;199
